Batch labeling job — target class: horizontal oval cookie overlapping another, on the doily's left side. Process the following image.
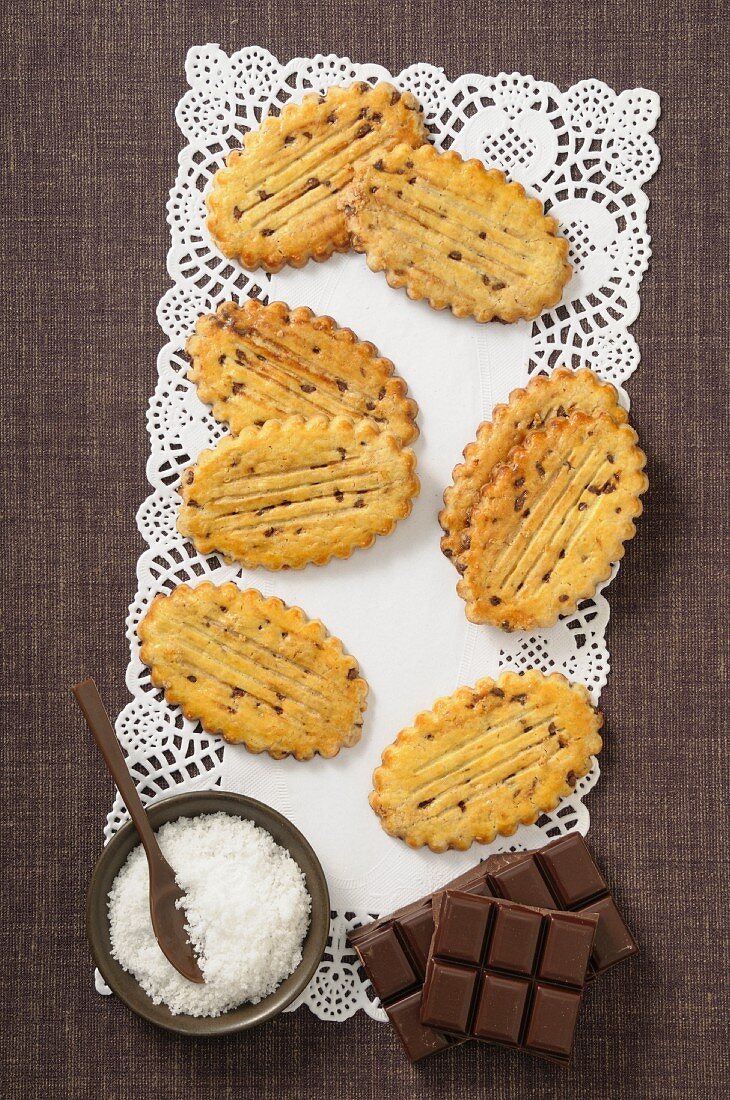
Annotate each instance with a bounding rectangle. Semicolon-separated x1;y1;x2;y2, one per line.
177;416;419;569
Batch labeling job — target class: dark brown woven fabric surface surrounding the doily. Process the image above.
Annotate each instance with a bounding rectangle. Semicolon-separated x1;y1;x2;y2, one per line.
0;0;730;1100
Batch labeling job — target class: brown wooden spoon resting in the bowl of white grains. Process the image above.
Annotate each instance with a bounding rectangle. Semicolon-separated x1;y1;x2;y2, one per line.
71;680;206;983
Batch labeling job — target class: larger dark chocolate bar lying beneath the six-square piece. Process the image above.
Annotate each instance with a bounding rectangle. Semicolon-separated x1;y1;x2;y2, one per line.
349;833;638;1062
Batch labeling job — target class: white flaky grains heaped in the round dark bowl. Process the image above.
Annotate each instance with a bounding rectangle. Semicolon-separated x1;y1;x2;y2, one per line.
109;813;311;1016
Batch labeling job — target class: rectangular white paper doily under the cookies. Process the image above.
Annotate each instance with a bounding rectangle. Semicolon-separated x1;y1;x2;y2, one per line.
104;45;659;1020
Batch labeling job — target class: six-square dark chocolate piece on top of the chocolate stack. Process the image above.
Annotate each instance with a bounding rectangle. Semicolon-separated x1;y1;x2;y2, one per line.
421;890;599;1066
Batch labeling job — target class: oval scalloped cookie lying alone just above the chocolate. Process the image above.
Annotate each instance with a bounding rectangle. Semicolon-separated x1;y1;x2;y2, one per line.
370;669;602;851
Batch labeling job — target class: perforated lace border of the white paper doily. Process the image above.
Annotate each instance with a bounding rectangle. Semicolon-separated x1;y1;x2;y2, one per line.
97;45;659;1020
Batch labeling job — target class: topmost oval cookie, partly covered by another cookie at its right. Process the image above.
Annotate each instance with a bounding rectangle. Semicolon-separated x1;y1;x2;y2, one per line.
208;84;428;272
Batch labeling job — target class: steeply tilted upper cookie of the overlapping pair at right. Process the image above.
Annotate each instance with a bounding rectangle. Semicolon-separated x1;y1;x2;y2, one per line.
457;411;649;630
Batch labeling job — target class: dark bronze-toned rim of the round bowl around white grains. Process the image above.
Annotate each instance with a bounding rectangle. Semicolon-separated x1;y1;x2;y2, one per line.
86;791;330;1035
